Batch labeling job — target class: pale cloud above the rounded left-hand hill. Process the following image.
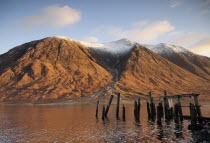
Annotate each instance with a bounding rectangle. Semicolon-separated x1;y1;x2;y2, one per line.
19;5;81;28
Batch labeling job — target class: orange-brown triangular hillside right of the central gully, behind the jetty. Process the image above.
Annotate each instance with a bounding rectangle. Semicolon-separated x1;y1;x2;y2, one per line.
116;46;210;98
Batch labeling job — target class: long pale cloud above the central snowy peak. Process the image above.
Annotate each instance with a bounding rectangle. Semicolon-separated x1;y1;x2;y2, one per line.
94;20;175;42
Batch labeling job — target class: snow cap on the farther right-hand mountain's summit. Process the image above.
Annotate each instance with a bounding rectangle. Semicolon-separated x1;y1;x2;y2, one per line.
145;43;189;54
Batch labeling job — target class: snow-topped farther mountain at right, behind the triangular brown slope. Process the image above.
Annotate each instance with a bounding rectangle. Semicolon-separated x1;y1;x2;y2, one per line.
145;43;210;80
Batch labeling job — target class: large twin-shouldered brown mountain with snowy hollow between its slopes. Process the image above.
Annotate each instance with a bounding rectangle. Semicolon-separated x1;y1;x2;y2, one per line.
0;36;210;103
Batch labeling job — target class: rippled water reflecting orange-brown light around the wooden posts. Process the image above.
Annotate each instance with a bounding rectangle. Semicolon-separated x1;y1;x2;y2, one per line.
0;103;210;143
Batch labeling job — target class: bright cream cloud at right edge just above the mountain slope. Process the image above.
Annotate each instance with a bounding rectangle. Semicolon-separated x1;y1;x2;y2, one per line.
189;36;210;57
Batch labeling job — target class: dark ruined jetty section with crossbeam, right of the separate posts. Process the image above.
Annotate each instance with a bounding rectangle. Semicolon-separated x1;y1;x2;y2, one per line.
147;91;210;130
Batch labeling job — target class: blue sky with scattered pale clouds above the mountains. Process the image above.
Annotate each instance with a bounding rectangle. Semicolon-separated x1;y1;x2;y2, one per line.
0;0;210;57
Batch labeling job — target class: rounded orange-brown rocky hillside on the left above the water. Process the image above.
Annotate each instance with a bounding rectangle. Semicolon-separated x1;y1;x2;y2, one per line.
0;37;113;102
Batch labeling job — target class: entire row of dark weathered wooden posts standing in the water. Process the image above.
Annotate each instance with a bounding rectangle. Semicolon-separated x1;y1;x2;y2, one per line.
96;91;208;125
